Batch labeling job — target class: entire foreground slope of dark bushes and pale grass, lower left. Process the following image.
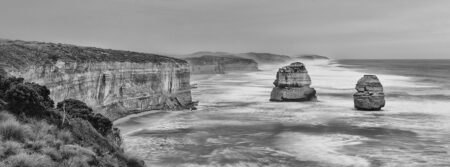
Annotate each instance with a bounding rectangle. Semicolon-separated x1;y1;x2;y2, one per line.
0;76;144;167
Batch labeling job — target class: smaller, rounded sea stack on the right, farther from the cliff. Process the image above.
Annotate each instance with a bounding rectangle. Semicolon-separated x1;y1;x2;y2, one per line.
353;75;385;111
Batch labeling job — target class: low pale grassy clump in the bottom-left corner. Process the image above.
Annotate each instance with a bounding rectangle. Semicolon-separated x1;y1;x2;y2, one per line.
4;153;56;167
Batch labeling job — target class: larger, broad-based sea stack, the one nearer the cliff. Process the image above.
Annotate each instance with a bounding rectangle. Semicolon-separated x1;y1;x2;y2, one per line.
270;62;317;102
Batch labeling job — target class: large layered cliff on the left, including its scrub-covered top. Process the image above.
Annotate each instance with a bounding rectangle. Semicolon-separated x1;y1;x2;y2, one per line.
0;41;192;119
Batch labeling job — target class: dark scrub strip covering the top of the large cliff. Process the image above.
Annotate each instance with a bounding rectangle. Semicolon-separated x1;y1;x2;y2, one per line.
0;40;187;70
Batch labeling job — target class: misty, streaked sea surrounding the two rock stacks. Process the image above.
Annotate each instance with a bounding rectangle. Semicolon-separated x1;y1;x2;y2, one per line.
115;60;450;167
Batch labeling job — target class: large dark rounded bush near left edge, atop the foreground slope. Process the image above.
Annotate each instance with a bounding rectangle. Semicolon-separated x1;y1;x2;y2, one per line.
5;84;45;116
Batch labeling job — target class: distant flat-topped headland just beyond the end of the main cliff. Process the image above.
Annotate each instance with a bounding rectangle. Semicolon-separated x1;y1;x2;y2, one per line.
185;55;258;74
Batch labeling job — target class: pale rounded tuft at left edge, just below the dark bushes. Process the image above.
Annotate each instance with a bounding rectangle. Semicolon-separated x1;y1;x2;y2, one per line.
0;119;31;142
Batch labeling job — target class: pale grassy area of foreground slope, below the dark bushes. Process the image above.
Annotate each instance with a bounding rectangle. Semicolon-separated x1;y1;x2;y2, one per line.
0;111;96;167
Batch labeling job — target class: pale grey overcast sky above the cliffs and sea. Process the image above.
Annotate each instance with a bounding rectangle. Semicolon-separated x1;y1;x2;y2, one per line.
0;0;450;59
